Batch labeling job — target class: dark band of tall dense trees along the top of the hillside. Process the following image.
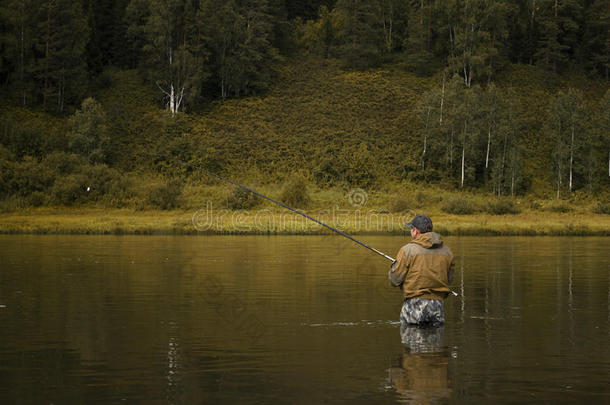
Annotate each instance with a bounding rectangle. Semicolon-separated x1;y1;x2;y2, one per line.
0;0;610;112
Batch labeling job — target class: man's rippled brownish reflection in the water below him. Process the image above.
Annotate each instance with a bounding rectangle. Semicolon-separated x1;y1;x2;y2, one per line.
390;324;451;404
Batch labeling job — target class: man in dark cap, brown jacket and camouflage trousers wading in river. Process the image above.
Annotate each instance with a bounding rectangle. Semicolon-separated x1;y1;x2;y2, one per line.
388;214;454;326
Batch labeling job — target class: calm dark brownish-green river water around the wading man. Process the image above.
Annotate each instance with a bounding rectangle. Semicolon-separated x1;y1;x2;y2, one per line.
0;236;610;404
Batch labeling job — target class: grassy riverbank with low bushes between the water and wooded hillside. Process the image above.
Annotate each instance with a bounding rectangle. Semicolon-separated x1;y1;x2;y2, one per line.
0;176;610;236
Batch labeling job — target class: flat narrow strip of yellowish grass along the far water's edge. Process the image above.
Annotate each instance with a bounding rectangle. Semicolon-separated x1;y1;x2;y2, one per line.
0;208;610;236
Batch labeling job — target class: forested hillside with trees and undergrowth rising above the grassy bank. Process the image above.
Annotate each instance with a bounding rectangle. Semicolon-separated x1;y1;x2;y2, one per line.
0;0;610;208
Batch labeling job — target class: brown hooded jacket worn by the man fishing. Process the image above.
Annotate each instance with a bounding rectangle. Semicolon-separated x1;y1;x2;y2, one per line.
389;232;454;300
